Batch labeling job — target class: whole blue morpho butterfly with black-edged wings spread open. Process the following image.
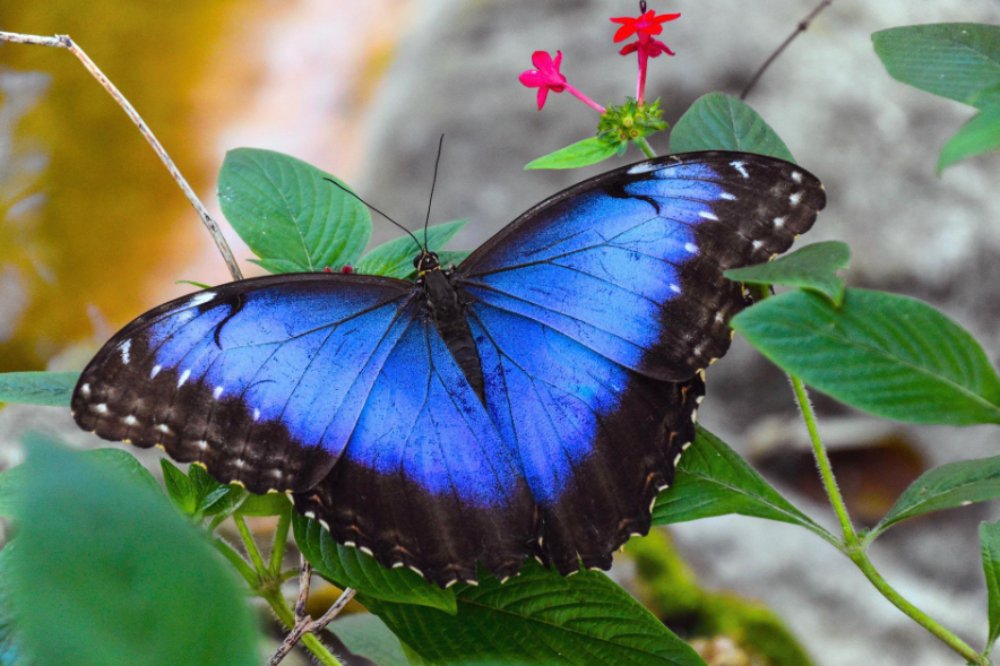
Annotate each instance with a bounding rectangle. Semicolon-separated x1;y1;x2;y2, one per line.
72;152;825;585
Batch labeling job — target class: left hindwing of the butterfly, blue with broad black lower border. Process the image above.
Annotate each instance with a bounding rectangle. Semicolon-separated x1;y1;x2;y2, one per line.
296;320;537;585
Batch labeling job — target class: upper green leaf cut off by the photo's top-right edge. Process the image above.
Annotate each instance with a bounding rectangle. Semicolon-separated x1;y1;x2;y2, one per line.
872;23;1000;107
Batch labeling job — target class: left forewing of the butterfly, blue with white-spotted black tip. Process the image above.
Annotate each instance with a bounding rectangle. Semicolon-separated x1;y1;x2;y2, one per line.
71;273;413;492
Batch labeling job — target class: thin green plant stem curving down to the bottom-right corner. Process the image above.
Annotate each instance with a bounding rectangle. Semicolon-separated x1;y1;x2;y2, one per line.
789;375;990;666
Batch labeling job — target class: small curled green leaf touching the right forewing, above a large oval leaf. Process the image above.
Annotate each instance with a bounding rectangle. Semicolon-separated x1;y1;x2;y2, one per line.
724;241;851;305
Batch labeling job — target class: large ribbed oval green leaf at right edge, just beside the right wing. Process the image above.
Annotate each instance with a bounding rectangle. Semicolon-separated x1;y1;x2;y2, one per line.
732;289;1000;425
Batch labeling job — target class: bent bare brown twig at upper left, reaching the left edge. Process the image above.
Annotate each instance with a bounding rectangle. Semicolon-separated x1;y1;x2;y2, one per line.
0;31;243;280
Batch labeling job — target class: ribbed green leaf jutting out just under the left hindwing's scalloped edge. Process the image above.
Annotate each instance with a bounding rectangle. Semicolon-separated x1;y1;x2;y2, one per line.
292;512;455;613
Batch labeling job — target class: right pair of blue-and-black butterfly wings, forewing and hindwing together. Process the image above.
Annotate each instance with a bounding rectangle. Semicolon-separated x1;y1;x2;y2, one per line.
454;153;825;572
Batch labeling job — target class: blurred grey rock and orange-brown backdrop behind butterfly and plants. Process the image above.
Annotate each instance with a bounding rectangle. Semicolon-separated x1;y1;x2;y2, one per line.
0;0;1000;666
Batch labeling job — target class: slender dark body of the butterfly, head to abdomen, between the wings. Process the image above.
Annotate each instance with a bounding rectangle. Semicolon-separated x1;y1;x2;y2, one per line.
414;253;486;404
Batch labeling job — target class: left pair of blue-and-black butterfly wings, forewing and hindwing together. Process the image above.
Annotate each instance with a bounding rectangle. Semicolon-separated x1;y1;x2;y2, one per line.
72;273;536;585
